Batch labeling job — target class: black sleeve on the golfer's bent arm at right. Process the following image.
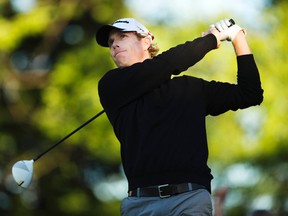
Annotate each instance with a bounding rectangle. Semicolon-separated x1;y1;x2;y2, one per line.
204;54;264;115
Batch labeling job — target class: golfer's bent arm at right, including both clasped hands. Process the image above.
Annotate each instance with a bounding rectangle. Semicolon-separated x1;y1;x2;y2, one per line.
206;20;263;115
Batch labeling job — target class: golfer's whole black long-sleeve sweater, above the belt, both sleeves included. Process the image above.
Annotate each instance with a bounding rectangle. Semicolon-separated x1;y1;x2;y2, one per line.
98;34;263;190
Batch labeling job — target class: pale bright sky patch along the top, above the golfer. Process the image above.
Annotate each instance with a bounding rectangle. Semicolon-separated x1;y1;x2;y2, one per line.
125;0;266;25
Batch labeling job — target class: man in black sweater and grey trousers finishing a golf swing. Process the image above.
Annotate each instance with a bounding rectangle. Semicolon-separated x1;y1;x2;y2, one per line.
96;18;263;216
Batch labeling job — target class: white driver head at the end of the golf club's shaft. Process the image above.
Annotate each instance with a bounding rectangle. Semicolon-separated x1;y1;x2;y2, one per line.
12;160;34;188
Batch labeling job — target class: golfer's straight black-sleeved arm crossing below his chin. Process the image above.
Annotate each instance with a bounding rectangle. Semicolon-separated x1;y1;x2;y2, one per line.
98;34;216;116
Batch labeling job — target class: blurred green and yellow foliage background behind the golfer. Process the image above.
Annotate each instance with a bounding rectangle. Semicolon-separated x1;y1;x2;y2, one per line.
0;0;288;216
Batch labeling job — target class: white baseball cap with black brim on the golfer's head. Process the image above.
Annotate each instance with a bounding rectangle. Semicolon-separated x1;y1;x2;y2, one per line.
96;18;154;47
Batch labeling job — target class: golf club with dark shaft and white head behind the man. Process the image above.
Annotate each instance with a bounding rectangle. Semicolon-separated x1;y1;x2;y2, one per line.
12;110;104;188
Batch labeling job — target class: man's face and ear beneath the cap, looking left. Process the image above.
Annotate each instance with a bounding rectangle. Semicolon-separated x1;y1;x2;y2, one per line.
108;30;150;68
